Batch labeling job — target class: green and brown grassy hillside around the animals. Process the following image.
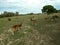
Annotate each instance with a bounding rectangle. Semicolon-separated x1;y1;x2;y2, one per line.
0;14;60;45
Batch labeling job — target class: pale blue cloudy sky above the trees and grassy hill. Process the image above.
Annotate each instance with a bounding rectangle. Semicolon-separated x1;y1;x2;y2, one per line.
0;0;60;13
